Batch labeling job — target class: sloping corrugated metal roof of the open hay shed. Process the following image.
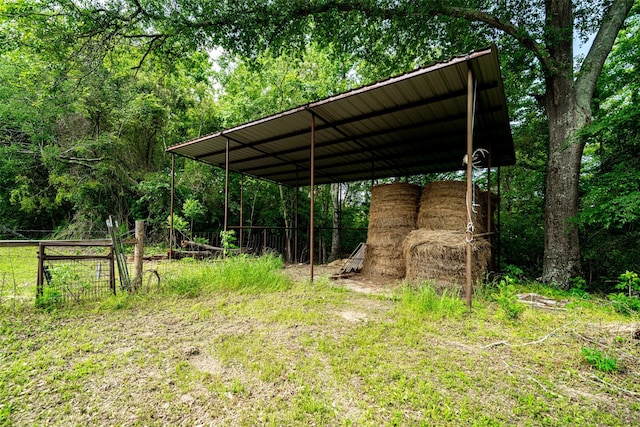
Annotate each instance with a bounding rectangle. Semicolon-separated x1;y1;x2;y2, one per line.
167;48;515;186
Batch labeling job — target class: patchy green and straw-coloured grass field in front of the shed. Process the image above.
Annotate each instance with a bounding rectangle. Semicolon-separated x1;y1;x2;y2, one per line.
0;252;640;426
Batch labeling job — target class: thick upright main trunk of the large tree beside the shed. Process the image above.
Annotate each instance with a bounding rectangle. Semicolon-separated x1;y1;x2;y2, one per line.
542;0;586;288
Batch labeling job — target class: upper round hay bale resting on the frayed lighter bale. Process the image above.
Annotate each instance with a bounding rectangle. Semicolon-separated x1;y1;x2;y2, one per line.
418;181;487;233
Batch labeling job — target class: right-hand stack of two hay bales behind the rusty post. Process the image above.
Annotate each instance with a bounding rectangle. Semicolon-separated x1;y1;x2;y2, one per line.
403;181;493;289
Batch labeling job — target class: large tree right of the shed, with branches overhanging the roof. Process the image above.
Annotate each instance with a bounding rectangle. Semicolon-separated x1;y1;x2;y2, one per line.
18;0;634;286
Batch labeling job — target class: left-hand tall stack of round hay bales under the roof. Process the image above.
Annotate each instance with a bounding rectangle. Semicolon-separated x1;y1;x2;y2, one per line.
362;183;421;279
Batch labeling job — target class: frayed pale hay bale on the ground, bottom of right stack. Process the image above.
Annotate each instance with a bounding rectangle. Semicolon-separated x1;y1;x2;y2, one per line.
403;229;491;290
